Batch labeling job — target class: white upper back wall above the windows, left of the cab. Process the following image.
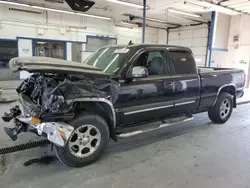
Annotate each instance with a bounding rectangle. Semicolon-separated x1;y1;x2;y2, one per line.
0;5;167;79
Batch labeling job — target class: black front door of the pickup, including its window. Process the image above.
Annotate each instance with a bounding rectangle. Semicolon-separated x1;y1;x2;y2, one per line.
115;48;174;125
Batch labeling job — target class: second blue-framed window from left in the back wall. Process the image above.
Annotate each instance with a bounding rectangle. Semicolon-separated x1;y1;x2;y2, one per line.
34;40;65;59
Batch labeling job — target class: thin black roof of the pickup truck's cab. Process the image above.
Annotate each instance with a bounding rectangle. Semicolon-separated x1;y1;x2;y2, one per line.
106;44;191;51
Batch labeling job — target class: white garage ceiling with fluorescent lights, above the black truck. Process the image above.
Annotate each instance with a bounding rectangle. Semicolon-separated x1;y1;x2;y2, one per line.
0;0;244;27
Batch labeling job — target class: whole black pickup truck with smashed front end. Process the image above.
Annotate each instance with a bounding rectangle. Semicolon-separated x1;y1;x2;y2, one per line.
3;45;245;167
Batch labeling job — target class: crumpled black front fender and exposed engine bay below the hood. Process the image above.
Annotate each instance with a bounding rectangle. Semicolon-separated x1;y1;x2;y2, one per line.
17;73;118;117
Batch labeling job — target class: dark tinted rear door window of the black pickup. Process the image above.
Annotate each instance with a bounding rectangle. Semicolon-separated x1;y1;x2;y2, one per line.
170;52;196;74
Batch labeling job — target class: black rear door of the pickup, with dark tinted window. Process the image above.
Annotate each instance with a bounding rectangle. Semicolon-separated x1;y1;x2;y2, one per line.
168;50;200;113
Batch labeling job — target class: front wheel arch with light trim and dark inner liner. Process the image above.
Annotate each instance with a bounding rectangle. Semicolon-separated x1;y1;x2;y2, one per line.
67;98;117;141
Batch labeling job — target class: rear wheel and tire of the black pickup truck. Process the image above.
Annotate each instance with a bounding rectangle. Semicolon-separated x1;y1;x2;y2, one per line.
208;92;233;124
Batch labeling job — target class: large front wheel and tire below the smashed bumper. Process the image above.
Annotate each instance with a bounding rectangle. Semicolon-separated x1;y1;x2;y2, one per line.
55;112;110;167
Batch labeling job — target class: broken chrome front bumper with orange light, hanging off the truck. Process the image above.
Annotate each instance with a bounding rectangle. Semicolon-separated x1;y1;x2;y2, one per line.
2;106;74;147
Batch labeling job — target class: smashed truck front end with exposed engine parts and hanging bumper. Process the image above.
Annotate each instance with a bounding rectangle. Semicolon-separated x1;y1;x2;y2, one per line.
2;73;74;146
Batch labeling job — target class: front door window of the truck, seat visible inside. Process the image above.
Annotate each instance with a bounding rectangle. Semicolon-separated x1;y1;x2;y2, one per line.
133;50;166;76
